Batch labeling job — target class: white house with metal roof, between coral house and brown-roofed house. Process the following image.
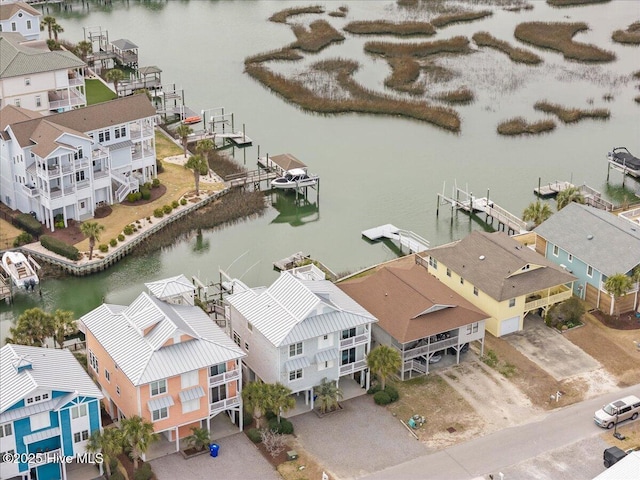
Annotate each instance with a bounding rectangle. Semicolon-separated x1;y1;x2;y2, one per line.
226;271;377;409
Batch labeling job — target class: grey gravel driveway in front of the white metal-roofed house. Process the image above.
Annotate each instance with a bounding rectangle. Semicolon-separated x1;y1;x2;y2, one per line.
293;395;427;480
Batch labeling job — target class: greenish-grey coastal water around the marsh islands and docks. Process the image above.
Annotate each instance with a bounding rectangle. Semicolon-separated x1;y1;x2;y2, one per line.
0;0;640;340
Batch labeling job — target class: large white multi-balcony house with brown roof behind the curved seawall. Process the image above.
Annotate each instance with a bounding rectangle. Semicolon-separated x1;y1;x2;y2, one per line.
0;95;157;230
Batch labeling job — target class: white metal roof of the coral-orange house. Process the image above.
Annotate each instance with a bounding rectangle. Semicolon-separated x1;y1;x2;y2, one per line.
81;286;245;385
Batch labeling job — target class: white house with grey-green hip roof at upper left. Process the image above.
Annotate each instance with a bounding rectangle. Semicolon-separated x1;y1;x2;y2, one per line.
0;33;87;115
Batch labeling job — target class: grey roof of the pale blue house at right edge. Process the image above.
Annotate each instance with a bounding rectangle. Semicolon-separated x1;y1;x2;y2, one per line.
533;202;640;276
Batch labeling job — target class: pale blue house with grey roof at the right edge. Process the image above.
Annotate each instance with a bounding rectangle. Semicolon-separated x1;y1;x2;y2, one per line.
533;203;640;315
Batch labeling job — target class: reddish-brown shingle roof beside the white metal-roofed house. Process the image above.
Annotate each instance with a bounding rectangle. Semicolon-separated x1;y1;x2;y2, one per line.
338;264;488;343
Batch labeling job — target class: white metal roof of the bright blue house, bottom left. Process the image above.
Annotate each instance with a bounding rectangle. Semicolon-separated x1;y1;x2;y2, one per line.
0;344;102;413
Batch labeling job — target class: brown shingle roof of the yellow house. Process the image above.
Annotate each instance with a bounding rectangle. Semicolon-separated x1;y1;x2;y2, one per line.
423;231;576;301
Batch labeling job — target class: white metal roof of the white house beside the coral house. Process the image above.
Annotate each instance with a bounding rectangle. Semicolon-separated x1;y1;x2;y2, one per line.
227;272;376;347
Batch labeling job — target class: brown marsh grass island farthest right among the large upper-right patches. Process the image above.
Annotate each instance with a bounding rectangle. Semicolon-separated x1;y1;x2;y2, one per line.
514;22;616;63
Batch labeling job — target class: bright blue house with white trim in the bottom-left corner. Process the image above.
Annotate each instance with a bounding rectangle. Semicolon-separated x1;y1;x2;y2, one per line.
0;345;102;480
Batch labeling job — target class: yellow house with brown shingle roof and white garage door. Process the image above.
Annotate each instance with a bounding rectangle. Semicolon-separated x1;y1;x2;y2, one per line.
420;232;576;337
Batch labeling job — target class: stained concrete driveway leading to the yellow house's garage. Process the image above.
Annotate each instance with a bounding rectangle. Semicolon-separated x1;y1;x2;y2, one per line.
502;315;602;381
